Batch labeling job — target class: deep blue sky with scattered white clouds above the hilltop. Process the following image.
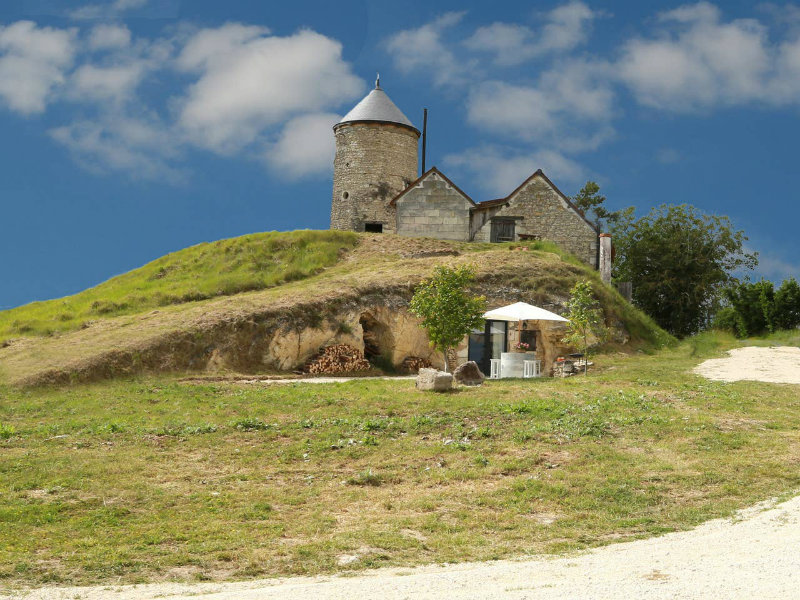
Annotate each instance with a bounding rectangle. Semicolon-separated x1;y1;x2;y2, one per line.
0;0;800;308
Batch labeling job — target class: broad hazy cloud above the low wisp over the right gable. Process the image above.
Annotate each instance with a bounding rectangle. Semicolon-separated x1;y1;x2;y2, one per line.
467;61;615;152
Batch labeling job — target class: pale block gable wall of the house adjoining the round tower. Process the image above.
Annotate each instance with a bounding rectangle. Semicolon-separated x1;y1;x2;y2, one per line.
396;172;473;242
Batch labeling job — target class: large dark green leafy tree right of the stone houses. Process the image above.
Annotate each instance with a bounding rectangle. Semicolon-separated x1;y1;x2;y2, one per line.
612;204;758;336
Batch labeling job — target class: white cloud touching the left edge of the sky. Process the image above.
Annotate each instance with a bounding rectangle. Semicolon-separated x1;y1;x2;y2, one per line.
0;21;76;115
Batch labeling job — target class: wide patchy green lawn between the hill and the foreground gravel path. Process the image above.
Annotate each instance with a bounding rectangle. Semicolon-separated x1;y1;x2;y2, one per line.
0;334;800;586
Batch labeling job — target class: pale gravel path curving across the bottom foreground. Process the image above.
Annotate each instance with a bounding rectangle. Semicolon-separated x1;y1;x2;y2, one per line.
6;497;800;600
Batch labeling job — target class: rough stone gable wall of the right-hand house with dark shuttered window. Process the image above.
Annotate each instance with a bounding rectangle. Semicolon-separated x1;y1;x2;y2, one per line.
473;176;597;266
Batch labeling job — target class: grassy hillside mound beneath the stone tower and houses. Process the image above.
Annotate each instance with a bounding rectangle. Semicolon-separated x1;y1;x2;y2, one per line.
0;231;670;384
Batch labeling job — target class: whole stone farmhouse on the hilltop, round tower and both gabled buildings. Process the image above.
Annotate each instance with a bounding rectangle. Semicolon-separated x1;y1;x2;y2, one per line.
331;79;611;275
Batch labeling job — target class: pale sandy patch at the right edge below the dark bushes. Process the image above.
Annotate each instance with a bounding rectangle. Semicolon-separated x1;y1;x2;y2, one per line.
694;346;800;382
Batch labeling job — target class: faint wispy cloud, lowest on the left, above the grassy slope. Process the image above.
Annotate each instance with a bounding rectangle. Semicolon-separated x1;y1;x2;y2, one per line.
49;114;184;183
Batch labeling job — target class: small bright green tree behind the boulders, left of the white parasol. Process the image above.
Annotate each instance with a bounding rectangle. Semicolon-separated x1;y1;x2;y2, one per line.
410;266;486;372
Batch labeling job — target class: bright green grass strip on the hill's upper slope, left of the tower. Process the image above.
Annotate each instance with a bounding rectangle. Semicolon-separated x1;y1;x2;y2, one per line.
0;231;358;341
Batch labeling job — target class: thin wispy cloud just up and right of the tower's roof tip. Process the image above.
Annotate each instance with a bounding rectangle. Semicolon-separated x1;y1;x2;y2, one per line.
386;12;475;85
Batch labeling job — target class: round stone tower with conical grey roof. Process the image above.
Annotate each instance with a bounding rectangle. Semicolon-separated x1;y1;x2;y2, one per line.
331;78;419;233
